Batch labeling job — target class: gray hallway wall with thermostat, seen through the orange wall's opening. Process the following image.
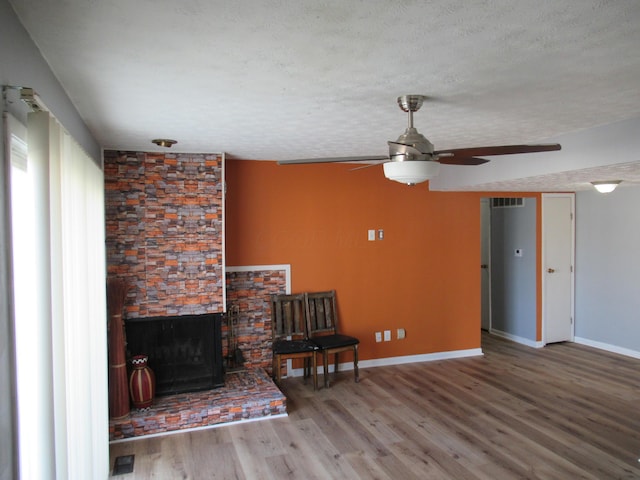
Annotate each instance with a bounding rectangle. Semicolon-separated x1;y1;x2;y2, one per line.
491;198;537;342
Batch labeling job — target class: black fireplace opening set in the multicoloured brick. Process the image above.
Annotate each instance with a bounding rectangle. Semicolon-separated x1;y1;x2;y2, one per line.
125;314;224;396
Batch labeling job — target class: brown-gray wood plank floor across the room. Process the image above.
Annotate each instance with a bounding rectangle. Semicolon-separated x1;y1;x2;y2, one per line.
110;335;640;480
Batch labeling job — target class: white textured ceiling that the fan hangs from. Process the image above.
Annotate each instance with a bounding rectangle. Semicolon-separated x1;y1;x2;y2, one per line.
10;0;640;190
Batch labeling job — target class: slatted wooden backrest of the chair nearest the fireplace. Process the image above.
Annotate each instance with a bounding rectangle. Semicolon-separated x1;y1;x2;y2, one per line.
271;293;307;340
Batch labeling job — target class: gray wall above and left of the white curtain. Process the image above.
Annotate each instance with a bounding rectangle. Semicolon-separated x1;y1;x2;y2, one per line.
0;0;102;480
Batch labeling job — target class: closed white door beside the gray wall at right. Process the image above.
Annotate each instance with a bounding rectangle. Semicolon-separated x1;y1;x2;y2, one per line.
542;194;575;344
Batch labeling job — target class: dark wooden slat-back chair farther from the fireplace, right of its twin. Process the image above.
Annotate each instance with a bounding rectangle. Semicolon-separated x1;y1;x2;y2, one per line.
305;290;360;388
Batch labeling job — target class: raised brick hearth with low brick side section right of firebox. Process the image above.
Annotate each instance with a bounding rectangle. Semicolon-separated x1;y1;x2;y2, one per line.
109;265;290;441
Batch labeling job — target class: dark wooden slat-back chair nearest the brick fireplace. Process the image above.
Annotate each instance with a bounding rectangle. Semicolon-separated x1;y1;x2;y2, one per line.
271;293;318;390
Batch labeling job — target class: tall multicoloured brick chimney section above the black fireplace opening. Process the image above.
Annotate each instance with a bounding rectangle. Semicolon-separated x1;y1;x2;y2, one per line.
104;150;224;319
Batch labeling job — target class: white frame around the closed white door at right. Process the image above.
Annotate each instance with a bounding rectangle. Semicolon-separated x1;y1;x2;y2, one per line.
540;193;576;345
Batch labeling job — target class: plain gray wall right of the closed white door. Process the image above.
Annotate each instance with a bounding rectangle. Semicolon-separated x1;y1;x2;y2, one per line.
575;186;640;353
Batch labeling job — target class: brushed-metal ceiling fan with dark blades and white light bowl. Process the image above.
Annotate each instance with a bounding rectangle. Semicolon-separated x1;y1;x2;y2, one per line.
278;95;561;185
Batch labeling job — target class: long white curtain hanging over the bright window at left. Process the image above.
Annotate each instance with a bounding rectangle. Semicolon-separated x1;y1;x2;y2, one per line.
11;112;109;479
